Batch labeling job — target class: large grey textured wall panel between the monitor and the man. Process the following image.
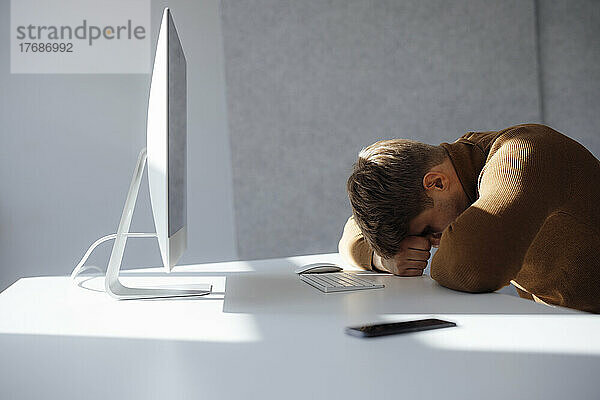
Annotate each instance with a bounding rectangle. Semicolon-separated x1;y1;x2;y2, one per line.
222;0;539;259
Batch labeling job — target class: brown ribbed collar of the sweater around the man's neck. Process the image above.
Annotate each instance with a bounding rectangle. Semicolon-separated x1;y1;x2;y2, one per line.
440;139;487;203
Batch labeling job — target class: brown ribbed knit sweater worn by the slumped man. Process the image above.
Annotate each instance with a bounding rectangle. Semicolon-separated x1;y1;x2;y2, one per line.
339;124;600;313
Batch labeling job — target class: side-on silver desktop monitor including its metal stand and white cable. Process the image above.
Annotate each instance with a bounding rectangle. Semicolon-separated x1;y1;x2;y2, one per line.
71;8;211;300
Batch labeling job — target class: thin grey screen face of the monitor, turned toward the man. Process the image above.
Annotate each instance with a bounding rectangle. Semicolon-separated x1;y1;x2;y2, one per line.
168;19;187;237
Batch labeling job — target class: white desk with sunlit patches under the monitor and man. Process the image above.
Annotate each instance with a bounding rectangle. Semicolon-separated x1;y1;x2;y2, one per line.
0;254;600;400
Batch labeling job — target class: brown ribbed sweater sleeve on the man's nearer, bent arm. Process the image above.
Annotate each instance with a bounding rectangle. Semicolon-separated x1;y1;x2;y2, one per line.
431;129;564;292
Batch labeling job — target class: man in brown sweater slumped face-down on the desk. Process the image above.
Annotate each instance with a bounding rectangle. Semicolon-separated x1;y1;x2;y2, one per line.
339;124;600;313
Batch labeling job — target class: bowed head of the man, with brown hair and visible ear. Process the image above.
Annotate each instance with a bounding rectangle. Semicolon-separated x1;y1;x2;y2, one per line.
347;139;469;258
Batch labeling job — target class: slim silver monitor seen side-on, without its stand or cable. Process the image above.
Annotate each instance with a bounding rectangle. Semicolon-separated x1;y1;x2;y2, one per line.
146;8;187;271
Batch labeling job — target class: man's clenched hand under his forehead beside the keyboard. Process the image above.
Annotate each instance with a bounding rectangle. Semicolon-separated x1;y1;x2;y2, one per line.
373;236;431;276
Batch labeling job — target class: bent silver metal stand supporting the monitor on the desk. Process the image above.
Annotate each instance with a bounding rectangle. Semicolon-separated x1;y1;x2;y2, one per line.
104;148;212;300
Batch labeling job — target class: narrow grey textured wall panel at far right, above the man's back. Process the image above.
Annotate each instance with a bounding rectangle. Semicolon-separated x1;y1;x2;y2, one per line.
539;0;600;157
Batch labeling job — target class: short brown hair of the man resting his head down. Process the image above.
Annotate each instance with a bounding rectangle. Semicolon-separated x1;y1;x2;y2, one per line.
347;139;447;258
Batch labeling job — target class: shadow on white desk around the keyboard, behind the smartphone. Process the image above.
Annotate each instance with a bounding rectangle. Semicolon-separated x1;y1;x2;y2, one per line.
223;273;577;314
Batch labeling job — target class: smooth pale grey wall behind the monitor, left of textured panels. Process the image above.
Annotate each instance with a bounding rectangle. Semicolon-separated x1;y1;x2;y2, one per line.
0;0;237;290
